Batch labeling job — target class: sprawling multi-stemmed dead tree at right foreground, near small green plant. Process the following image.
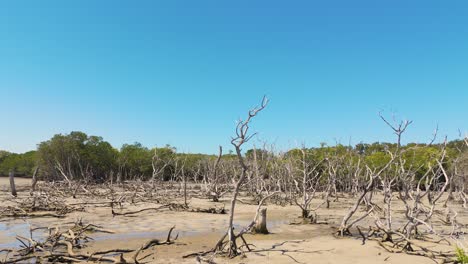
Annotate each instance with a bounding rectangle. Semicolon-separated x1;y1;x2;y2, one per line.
369;141;463;263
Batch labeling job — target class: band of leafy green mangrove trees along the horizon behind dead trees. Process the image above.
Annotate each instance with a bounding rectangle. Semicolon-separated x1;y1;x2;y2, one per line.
0;132;468;186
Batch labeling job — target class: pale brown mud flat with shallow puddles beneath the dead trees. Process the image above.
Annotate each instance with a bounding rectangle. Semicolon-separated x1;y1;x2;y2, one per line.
0;178;460;264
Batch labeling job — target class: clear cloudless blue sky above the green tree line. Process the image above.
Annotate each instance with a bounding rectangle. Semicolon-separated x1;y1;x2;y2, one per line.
0;0;468;153
